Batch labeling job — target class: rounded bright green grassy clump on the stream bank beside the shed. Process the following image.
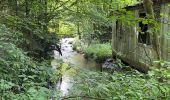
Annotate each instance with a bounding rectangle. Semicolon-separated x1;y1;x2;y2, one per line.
84;43;112;62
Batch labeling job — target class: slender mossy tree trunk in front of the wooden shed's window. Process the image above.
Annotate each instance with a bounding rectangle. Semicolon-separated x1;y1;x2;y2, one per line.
143;0;161;60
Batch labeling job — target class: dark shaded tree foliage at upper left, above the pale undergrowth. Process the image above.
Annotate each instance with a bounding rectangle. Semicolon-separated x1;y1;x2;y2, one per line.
0;0;58;58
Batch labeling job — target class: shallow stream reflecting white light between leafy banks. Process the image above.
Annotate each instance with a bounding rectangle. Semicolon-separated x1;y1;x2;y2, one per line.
51;38;102;96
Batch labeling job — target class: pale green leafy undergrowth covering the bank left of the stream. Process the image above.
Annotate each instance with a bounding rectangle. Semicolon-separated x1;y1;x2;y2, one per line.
0;25;57;100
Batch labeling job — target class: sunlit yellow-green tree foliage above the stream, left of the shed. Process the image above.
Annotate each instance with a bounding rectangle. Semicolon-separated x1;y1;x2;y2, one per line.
62;0;138;42
